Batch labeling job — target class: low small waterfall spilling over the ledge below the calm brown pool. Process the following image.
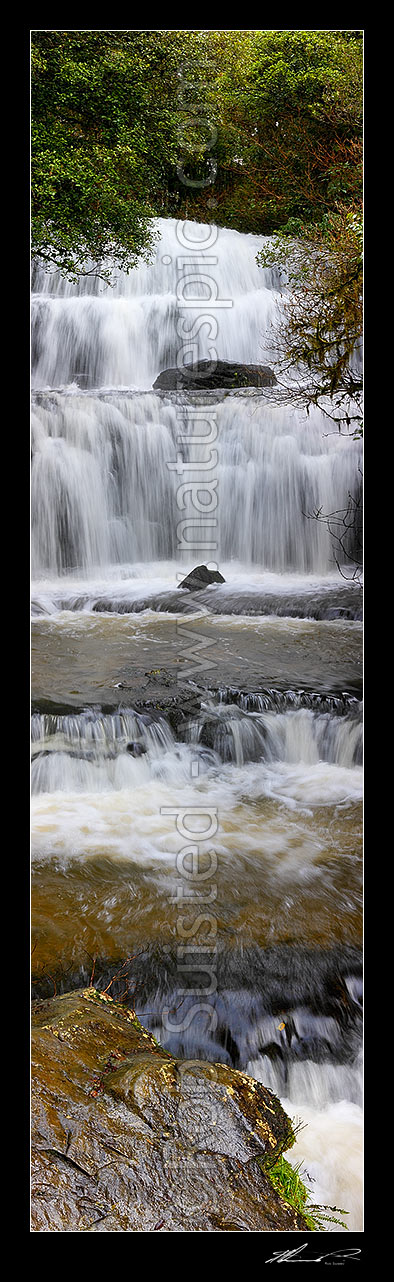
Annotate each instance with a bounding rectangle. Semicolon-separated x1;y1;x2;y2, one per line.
32;700;362;795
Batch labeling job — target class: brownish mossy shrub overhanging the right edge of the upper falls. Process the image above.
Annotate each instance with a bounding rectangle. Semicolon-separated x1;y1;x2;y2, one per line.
258;208;363;435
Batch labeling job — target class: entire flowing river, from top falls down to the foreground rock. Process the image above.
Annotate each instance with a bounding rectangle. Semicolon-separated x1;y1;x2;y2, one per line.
32;219;362;1228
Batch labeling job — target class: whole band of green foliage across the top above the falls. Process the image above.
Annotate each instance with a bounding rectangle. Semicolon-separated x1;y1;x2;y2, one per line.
32;31;362;273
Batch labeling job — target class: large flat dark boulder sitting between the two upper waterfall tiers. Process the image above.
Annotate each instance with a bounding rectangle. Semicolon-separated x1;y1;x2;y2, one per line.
153;360;276;391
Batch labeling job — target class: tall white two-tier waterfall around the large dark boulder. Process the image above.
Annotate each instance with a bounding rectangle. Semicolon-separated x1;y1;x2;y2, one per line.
32;219;361;578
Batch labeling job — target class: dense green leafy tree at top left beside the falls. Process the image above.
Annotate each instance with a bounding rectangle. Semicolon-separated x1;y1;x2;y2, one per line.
32;31;182;274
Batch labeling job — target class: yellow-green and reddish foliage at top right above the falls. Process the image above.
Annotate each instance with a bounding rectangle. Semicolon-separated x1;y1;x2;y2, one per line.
179;31;362;233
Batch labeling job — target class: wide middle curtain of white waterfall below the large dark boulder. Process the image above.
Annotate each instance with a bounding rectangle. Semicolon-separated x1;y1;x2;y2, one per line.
32;392;361;576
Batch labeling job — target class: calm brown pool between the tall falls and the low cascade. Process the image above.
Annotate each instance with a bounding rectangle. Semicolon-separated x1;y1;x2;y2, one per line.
32;612;362;706
